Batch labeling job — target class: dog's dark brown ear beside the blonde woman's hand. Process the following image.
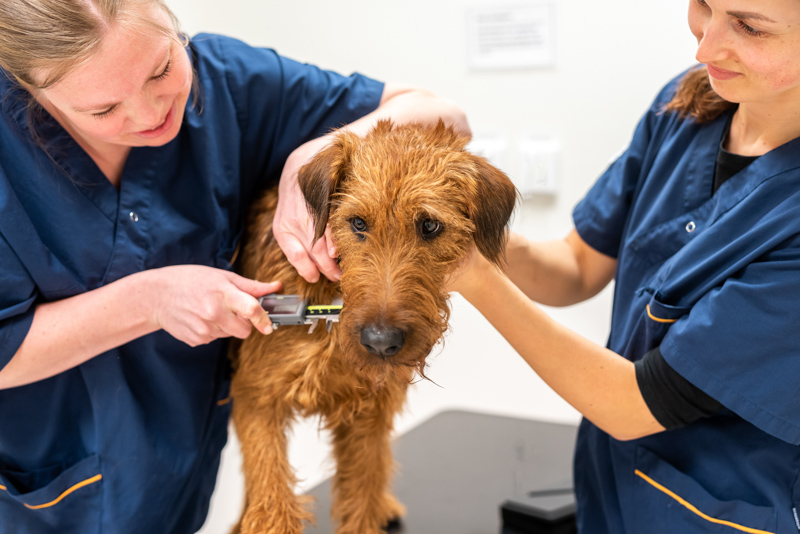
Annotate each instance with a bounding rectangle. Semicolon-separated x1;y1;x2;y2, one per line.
297;132;357;241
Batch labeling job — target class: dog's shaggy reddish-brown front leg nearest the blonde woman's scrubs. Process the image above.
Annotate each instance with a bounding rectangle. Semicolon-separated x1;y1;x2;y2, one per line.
233;396;313;534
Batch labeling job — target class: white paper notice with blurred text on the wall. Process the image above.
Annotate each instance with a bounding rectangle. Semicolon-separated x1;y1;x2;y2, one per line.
467;0;556;69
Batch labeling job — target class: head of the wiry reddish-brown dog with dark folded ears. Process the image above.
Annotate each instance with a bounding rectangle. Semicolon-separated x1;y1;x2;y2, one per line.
299;121;517;381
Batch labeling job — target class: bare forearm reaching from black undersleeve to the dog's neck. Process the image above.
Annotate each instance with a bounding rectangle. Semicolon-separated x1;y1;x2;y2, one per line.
462;264;664;440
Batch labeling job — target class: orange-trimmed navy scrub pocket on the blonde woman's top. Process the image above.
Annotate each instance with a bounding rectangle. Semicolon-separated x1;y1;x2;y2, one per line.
0;455;103;534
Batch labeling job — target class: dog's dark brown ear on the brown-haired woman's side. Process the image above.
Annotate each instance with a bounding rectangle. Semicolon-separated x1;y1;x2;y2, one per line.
469;156;518;268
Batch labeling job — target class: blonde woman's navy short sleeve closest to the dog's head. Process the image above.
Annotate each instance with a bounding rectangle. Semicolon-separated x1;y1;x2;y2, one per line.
203;33;384;187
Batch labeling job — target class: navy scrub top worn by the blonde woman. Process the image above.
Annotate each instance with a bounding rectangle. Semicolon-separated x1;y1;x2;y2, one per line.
0;35;383;534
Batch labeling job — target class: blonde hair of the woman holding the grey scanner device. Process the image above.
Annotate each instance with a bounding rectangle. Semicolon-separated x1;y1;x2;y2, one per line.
0;0;187;90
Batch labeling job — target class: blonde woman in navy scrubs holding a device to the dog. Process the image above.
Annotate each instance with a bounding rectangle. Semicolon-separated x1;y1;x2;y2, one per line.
0;0;468;534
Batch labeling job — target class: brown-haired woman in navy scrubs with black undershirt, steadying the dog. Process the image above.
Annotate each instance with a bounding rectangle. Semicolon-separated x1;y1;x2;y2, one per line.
452;0;800;534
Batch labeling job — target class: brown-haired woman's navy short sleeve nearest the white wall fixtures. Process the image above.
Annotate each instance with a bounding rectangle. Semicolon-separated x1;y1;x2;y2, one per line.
572;77;681;258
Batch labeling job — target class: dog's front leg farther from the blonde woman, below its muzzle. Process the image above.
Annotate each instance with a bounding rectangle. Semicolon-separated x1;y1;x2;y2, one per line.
331;406;405;534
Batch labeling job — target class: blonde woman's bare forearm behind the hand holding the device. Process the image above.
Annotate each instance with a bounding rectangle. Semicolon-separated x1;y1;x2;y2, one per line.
0;273;159;389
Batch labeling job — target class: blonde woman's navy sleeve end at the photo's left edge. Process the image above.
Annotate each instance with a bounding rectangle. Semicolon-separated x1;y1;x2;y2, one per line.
0;230;37;369
